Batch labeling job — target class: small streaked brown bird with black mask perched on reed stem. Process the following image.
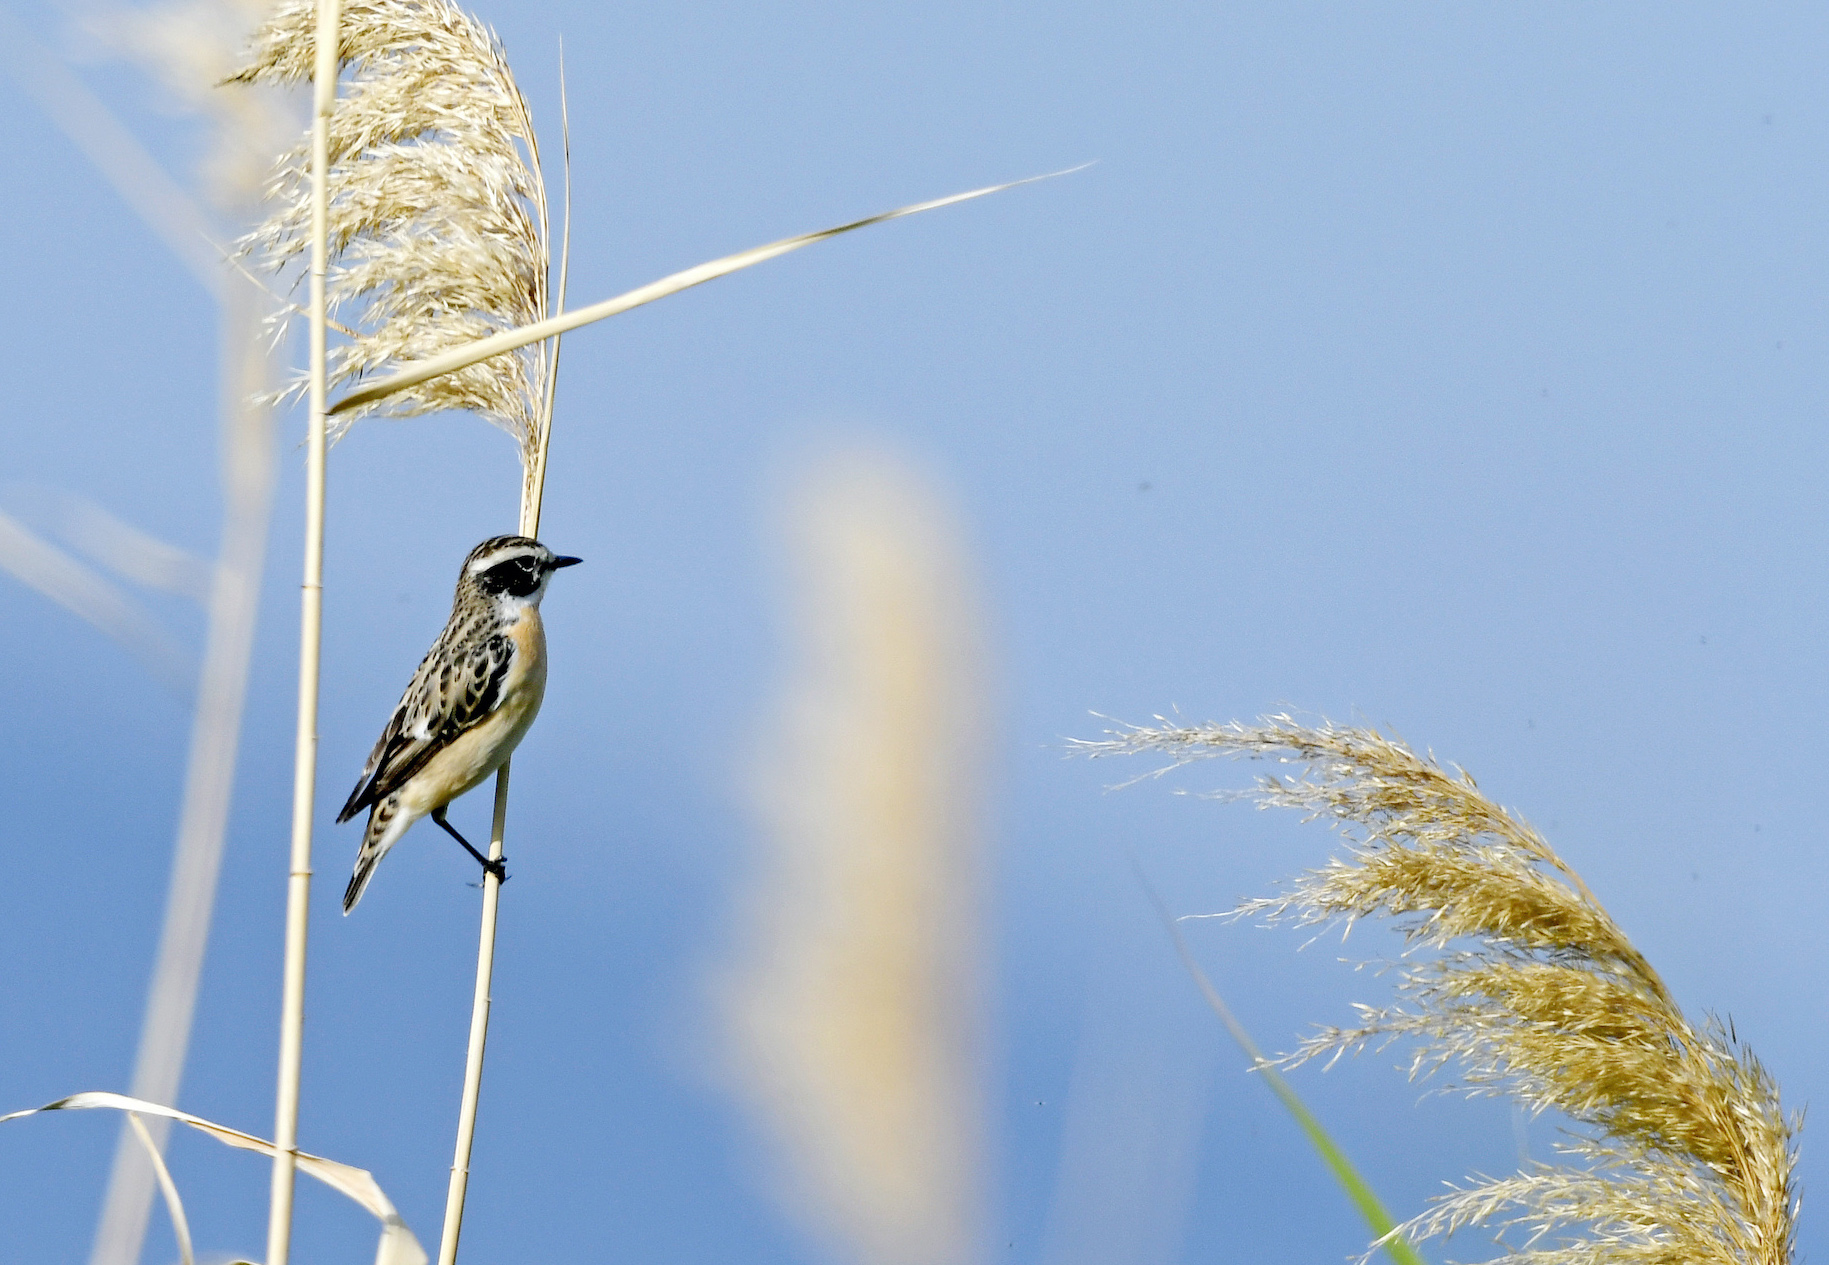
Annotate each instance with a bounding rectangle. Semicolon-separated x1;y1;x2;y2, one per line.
337;536;583;914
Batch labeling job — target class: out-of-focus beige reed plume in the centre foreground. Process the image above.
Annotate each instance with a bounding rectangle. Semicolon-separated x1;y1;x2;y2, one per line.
721;459;980;1265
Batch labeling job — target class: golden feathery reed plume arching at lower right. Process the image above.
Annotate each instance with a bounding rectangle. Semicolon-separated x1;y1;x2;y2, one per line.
1083;717;1798;1265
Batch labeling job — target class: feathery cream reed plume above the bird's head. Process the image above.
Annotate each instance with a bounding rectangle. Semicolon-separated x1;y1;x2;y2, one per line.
230;0;551;472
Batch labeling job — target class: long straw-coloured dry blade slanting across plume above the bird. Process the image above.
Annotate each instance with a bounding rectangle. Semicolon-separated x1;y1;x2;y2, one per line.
329;165;1088;417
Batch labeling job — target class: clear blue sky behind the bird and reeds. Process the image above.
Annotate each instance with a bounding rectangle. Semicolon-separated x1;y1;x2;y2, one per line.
0;0;1829;1265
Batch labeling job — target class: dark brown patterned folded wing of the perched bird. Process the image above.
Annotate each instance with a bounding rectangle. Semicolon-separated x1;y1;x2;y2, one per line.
337;627;516;823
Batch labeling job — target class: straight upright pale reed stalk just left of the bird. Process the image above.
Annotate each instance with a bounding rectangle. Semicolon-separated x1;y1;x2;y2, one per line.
267;0;340;1265
